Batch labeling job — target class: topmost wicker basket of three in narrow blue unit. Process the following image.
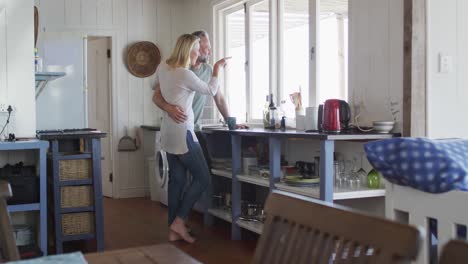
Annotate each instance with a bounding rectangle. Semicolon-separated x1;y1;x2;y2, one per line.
59;159;93;181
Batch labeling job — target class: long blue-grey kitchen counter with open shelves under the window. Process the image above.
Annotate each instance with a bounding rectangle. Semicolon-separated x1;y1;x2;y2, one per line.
203;127;400;240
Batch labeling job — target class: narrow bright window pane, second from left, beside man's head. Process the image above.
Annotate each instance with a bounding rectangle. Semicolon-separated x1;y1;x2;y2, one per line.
250;1;270;119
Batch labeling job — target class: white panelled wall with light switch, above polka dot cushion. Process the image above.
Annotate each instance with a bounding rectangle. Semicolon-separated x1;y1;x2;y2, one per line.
427;0;468;139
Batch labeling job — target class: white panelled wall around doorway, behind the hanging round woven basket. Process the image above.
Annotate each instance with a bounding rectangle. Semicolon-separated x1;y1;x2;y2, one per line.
36;0;177;198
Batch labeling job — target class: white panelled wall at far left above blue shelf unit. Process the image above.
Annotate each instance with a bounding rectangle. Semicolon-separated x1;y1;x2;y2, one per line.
0;0;36;137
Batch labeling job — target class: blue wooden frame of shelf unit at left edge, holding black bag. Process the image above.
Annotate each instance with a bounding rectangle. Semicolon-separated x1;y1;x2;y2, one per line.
0;139;49;255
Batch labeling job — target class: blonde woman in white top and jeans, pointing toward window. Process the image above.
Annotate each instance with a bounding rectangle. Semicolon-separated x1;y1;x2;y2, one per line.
156;34;226;243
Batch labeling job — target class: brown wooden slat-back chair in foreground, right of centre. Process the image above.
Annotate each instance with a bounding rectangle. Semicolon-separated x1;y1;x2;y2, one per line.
253;192;422;264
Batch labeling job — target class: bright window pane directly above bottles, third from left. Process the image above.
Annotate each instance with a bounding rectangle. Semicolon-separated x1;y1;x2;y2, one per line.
280;0;310;112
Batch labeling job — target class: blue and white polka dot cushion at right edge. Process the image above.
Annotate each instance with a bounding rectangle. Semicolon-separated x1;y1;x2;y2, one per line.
364;138;468;193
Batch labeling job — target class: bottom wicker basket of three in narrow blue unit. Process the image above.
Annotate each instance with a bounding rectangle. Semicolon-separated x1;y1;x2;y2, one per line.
62;212;94;236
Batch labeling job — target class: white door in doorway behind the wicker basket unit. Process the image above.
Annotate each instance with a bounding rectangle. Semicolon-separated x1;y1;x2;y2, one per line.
87;37;113;197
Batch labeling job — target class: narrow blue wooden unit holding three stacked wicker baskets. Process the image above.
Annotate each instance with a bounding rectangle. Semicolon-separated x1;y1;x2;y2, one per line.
38;130;106;254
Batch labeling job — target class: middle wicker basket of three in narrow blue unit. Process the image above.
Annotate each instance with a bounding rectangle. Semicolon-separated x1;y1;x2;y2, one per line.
60;185;94;208
